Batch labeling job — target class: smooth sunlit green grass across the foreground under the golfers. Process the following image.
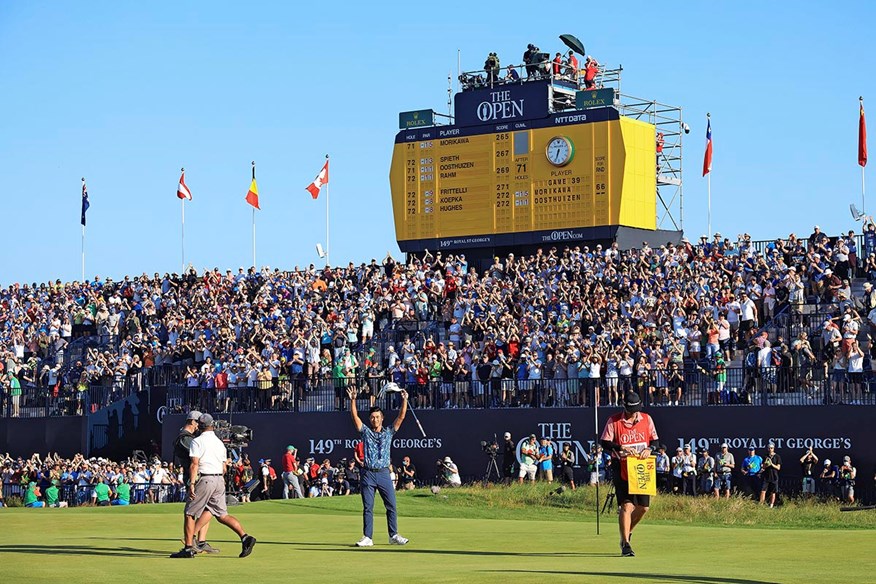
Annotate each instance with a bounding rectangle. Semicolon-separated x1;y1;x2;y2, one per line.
0;490;876;584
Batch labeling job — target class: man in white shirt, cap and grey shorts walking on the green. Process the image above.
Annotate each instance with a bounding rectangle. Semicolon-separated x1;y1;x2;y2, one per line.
170;414;256;558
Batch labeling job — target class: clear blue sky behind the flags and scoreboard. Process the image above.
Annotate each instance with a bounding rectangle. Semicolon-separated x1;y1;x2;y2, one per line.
0;0;876;285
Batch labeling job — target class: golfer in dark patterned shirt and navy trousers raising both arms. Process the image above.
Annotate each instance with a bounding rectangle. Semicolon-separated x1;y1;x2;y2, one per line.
347;387;408;547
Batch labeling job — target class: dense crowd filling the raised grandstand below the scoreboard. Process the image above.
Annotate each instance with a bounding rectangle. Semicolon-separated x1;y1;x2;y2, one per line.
0;223;876;415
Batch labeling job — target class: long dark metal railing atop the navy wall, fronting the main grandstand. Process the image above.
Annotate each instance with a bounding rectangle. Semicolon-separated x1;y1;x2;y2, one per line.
167;363;876;413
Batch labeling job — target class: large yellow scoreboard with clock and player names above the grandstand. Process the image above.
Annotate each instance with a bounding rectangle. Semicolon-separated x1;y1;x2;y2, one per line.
390;110;657;249
